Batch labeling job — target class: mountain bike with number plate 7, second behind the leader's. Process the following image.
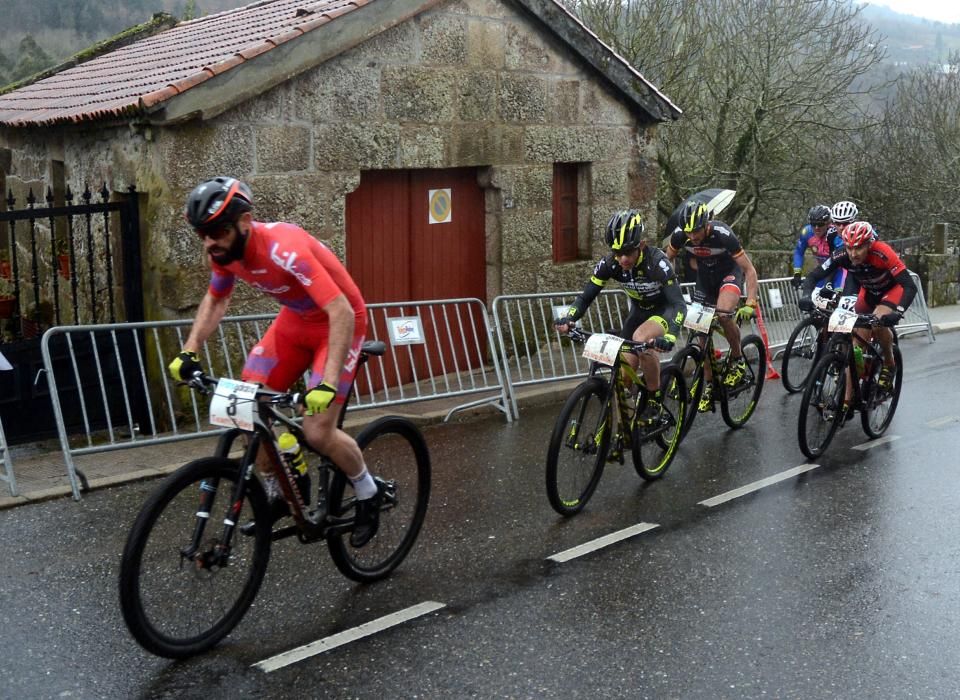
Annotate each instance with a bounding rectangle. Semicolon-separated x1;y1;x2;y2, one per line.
671;302;767;436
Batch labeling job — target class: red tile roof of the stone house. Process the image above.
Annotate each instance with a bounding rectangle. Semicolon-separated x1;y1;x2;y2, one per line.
0;0;372;126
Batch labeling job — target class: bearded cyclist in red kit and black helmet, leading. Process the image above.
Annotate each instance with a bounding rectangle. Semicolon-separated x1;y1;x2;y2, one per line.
169;177;380;547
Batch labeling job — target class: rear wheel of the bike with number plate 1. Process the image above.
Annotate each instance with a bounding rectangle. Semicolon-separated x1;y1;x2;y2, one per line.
632;364;687;481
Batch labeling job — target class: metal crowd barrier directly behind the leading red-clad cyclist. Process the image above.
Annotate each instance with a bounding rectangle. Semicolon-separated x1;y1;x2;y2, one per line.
37;299;512;500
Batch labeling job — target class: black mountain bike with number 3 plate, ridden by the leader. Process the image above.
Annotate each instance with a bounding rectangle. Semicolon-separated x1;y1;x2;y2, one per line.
119;341;430;658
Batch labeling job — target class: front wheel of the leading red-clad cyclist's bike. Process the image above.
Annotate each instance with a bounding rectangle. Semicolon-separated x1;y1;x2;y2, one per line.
120;457;270;659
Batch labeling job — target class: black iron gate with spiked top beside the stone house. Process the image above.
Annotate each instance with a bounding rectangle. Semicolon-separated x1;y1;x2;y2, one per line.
0;185;143;444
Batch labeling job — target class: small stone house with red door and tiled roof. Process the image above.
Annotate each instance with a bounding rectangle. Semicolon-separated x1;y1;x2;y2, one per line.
0;0;680;319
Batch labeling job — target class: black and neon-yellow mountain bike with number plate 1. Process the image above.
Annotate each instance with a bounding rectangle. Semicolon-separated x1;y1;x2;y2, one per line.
546;327;686;516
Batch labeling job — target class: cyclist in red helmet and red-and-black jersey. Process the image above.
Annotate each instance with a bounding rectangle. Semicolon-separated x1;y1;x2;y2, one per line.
797;221;917;396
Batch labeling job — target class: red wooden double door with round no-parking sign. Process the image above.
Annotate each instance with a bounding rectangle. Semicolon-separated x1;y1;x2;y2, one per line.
346;168;486;389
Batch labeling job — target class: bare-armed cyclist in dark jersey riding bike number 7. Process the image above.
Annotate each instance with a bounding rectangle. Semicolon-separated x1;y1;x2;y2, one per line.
666;199;758;413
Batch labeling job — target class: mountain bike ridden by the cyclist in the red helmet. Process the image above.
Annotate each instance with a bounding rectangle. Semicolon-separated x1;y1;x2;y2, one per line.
797;302;903;459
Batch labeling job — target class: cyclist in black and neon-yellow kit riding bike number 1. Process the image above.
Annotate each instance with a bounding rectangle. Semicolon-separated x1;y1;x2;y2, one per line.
557;209;686;423
